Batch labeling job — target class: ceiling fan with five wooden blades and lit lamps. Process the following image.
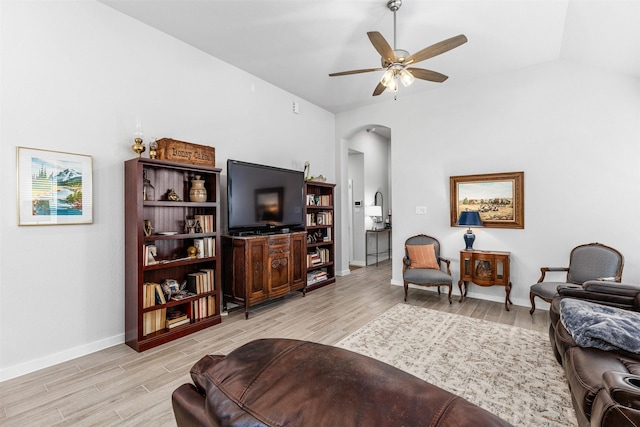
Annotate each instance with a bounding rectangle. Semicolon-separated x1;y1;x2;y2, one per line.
329;0;467;96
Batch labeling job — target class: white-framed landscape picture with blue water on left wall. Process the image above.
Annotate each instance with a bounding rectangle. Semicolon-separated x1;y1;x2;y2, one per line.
17;147;93;225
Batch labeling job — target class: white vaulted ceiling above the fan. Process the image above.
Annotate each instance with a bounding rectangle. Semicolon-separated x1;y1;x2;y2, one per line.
100;0;640;112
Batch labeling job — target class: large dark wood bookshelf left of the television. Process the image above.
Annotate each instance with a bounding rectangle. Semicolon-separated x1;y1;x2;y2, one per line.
124;158;222;351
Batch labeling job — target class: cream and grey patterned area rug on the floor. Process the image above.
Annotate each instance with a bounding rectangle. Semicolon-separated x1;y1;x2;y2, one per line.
336;304;578;426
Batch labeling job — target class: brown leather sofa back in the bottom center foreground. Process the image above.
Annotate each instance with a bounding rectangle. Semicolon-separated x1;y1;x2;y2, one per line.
172;339;510;427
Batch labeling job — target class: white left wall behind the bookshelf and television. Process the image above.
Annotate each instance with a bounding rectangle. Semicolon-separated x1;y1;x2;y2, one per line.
0;0;336;380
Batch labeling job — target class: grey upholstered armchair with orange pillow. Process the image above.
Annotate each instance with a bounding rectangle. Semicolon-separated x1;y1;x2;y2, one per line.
402;234;453;304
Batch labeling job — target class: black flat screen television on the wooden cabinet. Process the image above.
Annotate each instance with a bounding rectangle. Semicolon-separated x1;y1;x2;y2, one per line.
227;159;304;234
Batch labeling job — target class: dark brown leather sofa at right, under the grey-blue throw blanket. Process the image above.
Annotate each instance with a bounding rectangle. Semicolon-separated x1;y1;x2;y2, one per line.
549;281;640;427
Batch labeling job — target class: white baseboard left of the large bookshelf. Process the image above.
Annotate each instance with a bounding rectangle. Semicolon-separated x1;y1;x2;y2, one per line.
0;334;124;382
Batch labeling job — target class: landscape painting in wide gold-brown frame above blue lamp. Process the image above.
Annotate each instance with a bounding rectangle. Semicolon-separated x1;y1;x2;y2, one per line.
449;172;524;228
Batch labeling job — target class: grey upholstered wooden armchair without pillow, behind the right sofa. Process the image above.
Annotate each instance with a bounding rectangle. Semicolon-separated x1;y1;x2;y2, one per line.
529;243;624;314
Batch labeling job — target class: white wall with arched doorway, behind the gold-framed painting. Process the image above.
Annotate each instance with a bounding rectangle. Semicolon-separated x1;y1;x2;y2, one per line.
336;61;640;308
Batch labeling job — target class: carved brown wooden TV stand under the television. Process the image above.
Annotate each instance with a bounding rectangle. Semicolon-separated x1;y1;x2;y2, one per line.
222;231;307;319
